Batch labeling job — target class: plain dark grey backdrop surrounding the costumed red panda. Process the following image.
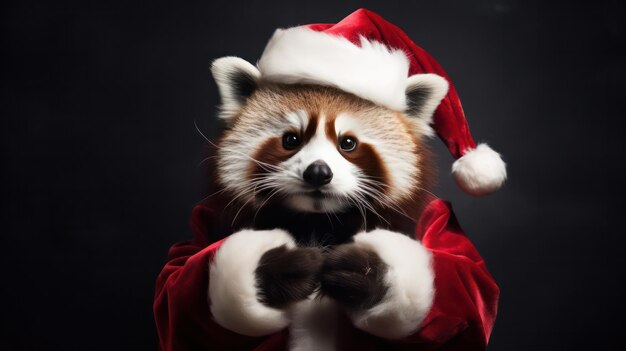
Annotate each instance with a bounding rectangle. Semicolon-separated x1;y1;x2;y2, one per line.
0;0;626;351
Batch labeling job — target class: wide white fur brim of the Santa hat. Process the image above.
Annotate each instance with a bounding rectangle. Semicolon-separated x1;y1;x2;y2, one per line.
258;27;409;111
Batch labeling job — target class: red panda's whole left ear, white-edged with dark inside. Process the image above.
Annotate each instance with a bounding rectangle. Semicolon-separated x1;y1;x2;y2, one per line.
211;56;261;122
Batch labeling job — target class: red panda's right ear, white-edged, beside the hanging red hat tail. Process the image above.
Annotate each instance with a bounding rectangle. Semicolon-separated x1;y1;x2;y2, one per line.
405;73;448;128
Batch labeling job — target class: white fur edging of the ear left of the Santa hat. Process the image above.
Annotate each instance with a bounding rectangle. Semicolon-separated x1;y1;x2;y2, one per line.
211;56;261;121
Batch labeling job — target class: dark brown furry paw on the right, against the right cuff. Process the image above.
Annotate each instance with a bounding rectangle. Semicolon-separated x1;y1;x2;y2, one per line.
320;244;388;310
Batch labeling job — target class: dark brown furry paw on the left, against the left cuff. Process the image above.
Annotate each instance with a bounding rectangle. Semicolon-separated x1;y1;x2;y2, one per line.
255;245;322;308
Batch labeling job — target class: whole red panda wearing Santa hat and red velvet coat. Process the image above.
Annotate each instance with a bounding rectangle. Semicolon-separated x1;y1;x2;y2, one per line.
155;9;506;351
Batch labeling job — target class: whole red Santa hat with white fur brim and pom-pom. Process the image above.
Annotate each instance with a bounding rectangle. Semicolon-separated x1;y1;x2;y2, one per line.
258;9;506;195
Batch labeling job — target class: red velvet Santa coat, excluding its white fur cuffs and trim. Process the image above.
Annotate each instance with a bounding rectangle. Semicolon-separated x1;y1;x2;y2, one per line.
154;199;499;351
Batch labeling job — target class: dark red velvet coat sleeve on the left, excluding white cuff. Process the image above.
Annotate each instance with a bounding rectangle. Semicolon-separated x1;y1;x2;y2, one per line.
153;205;286;351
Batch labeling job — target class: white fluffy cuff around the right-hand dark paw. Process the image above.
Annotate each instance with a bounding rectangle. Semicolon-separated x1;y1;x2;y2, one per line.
351;229;435;339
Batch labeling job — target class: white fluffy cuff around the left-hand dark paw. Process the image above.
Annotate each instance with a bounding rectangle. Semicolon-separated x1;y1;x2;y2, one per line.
209;229;295;336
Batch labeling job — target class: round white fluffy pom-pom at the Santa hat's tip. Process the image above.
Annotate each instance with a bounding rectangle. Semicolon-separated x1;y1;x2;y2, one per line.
452;144;506;196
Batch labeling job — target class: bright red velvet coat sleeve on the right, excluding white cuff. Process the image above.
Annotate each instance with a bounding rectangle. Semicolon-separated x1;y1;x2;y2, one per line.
407;200;500;351
